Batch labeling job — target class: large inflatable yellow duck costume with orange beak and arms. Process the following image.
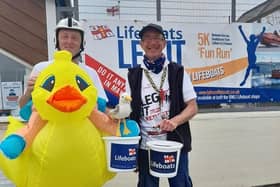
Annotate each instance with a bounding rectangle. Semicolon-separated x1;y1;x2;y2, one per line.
0;51;117;187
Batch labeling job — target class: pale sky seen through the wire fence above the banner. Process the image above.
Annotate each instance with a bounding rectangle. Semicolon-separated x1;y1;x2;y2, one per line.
79;0;265;23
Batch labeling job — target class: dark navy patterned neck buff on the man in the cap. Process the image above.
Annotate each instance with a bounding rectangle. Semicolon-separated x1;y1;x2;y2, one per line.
143;54;165;74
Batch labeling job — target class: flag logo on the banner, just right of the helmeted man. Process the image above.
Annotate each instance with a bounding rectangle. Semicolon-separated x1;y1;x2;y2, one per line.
89;25;115;40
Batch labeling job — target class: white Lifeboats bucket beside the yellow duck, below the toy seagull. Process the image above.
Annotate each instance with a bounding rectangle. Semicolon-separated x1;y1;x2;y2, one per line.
103;136;140;172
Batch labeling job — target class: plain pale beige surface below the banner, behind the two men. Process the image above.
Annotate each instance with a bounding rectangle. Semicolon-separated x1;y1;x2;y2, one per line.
0;111;280;187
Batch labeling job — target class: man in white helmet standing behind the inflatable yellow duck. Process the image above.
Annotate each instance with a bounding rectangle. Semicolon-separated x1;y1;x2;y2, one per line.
19;18;108;118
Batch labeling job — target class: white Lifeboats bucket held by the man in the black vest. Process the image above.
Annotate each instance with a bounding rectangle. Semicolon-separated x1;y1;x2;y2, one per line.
147;140;183;178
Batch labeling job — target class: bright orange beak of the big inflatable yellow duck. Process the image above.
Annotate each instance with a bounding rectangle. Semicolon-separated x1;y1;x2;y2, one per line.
47;86;87;112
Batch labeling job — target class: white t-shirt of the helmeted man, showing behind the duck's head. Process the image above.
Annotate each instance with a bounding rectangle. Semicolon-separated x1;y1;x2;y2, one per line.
30;60;108;101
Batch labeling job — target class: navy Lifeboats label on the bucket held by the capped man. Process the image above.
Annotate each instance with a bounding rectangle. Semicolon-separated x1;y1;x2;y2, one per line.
150;150;177;173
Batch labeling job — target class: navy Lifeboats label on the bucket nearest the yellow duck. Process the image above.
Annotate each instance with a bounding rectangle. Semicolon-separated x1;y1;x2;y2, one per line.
110;143;138;169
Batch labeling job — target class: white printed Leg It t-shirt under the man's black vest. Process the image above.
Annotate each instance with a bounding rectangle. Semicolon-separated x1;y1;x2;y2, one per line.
126;62;196;149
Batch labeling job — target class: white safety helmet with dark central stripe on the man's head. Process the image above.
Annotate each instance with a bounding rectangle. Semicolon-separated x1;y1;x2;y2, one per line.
55;17;85;52
